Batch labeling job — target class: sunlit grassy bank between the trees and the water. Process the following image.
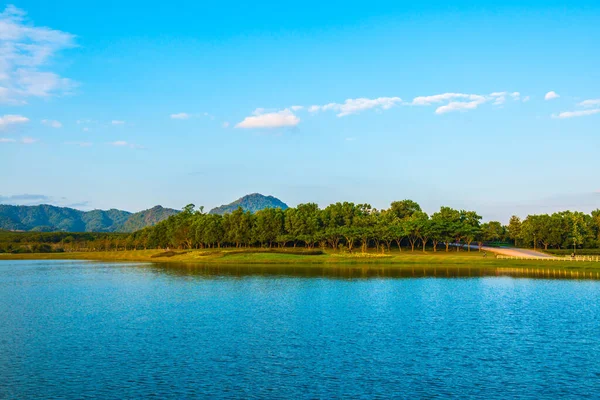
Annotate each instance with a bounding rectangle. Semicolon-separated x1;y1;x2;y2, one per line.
0;249;600;272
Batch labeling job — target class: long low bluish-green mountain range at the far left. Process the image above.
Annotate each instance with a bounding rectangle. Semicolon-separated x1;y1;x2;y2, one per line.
0;204;179;232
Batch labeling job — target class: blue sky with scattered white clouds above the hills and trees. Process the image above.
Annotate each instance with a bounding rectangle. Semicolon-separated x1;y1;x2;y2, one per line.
0;0;600;222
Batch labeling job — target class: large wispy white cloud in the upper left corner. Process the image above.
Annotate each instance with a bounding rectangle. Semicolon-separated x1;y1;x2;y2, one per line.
0;5;75;104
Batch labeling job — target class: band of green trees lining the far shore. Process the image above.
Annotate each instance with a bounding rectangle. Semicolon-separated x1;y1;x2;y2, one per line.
0;200;600;252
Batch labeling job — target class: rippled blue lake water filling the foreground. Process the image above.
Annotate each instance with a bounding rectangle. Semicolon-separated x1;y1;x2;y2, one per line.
0;261;600;399
